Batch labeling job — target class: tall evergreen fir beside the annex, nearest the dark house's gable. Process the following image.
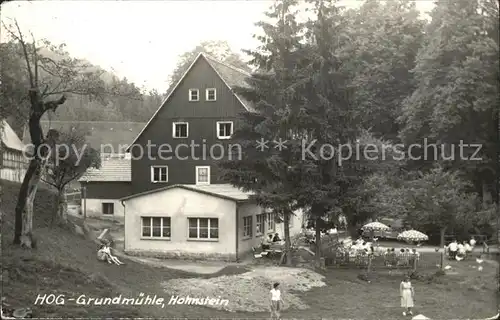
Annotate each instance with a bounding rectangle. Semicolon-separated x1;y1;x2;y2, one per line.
222;0;303;264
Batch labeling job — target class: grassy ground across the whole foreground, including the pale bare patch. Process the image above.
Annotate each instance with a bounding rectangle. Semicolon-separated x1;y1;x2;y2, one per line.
2;182;498;319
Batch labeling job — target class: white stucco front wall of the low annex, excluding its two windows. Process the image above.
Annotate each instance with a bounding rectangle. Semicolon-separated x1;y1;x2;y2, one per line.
124;188;236;259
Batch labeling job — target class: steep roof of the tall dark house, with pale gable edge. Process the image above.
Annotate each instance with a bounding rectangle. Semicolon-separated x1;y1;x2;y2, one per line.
130;52;255;150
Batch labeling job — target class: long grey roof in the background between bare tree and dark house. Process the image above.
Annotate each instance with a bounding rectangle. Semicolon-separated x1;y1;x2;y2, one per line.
23;121;145;153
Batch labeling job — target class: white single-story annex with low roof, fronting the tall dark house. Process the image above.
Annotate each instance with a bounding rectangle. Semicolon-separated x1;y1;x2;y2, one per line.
121;184;303;261
